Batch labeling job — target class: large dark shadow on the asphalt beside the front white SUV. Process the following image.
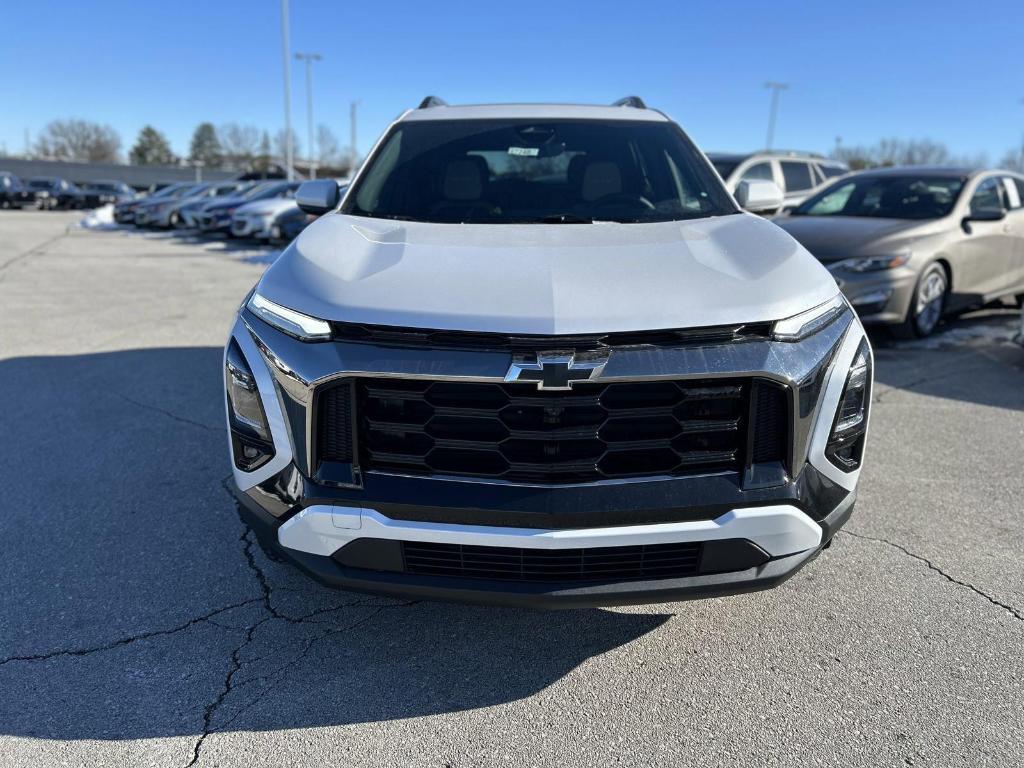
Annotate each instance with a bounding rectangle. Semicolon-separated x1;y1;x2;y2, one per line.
0;347;669;749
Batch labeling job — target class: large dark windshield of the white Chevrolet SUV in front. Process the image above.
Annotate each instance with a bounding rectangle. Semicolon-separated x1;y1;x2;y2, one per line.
342;120;737;224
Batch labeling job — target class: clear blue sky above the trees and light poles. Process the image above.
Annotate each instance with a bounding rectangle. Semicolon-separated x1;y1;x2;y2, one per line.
0;0;1024;162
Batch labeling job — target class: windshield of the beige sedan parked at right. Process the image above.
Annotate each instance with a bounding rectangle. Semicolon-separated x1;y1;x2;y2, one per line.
792;176;964;219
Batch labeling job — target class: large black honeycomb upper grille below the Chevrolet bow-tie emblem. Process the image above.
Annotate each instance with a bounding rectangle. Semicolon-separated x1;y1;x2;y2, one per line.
352;379;751;483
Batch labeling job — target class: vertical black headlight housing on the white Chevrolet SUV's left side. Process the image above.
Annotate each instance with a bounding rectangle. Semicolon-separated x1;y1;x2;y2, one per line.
224;341;273;472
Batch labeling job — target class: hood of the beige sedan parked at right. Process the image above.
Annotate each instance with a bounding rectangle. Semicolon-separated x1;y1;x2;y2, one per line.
775;216;948;263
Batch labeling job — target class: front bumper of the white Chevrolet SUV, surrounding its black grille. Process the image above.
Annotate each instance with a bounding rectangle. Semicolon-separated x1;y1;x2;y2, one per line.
228;311;864;607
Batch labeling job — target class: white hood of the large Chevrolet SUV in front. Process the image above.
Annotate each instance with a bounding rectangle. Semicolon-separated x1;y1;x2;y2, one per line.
258;214;838;334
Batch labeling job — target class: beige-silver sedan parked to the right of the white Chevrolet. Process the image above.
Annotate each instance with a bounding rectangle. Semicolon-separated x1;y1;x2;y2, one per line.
776;167;1024;336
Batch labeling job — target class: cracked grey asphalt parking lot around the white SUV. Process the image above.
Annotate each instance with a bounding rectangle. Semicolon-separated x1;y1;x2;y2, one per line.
0;211;1024;768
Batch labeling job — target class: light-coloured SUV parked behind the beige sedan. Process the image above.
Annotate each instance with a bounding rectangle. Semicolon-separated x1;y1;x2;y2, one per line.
708;150;850;210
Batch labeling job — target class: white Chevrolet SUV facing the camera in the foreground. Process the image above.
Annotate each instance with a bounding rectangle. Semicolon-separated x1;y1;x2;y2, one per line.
224;97;872;606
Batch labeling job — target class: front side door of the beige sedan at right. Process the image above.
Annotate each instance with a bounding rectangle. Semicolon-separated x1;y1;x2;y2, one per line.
953;176;1014;303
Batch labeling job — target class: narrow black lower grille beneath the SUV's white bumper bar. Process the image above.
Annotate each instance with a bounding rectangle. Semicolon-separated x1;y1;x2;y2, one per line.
401;542;702;583
